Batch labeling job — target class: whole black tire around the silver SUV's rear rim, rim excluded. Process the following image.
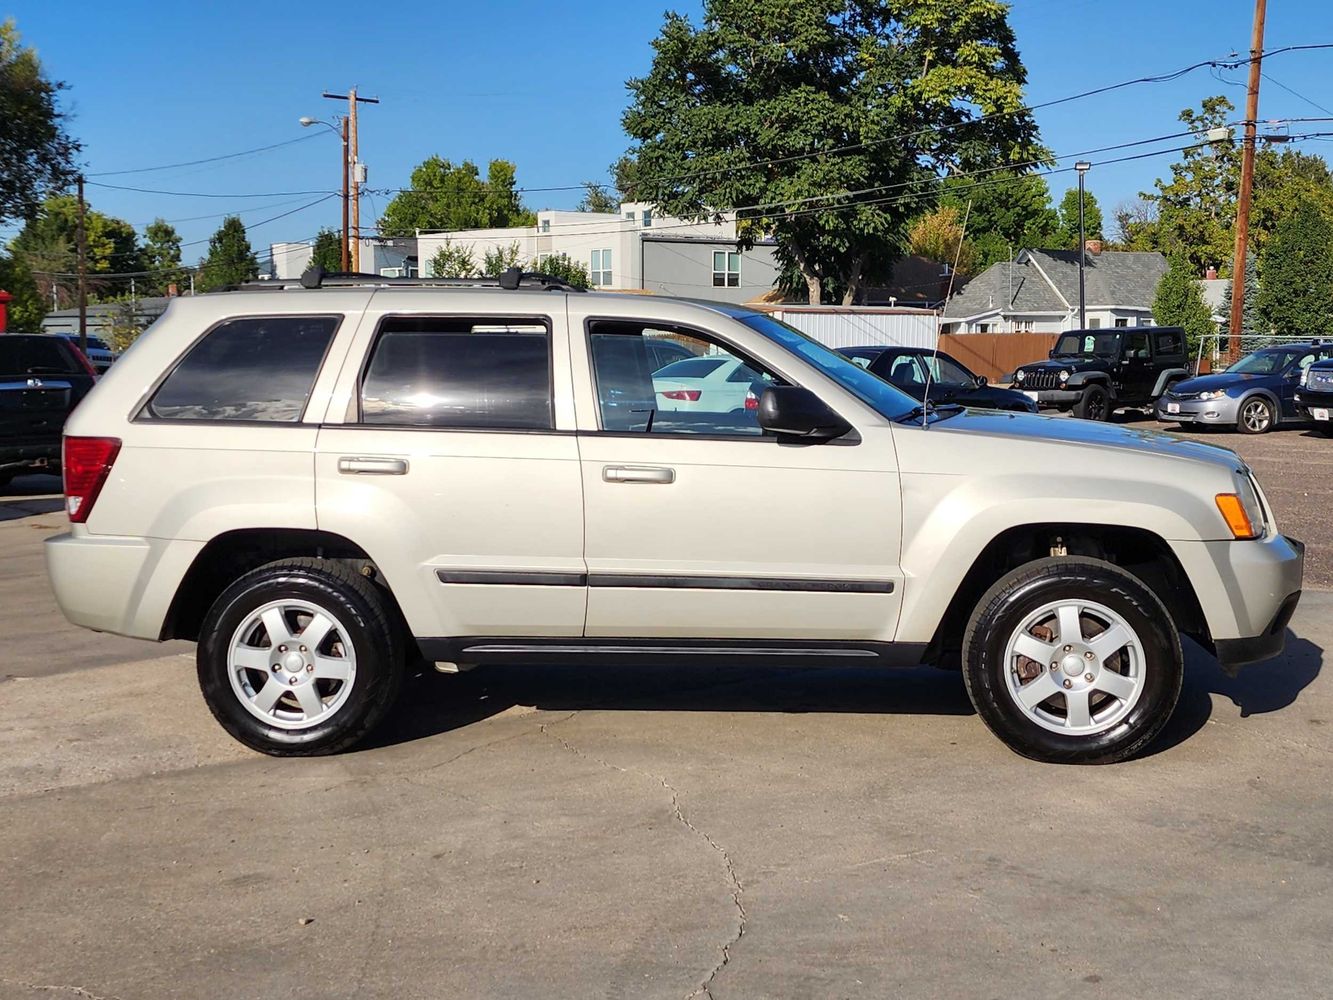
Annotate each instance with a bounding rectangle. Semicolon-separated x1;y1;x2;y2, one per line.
196;559;404;757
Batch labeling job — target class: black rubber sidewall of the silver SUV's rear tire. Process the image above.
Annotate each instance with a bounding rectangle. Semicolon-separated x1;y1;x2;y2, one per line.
196;569;393;753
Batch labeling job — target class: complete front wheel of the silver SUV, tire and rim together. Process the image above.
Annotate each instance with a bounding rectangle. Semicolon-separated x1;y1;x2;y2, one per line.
962;557;1184;764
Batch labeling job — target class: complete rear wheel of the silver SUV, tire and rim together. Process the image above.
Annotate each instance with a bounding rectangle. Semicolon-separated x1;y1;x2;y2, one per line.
197;559;403;756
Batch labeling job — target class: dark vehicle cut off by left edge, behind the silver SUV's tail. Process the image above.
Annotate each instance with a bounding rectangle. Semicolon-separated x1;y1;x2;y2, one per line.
0;333;96;485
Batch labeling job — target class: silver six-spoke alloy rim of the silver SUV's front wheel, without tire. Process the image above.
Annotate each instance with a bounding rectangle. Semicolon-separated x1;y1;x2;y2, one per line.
1004;600;1146;736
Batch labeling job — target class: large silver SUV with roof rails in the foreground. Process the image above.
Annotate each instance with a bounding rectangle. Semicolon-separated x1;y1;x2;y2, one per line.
47;272;1302;763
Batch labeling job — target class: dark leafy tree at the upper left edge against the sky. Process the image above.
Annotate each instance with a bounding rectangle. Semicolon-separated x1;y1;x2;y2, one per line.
0;20;81;220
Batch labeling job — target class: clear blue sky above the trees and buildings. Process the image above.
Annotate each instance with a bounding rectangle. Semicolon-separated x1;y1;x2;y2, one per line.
5;0;1333;261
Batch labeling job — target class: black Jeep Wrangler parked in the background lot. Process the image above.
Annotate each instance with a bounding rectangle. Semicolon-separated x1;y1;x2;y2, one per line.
1013;327;1189;420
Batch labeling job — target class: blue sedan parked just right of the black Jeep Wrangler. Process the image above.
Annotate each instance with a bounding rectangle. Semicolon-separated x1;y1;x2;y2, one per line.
1157;341;1333;435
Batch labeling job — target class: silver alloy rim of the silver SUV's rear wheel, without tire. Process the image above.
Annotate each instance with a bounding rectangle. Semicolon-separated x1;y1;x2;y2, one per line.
227;597;356;729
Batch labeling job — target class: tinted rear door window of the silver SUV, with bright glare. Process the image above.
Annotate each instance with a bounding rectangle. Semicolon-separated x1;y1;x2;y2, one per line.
361;316;552;429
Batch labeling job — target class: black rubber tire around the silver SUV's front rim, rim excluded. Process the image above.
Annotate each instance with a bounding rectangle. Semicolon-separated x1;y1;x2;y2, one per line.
962;557;1184;764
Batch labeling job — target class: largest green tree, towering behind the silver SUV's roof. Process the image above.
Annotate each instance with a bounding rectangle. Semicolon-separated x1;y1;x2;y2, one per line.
623;0;1040;303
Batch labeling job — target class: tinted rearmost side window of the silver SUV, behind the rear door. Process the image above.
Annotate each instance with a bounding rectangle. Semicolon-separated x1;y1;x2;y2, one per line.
145;316;339;423
